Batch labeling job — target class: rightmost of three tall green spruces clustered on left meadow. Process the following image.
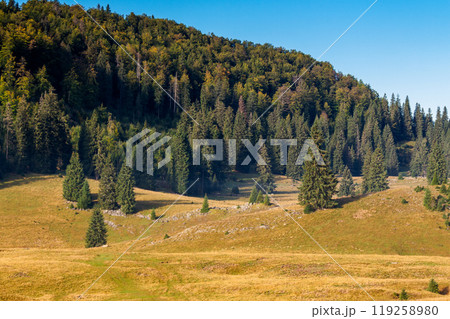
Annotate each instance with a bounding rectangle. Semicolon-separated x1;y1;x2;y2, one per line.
116;163;136;214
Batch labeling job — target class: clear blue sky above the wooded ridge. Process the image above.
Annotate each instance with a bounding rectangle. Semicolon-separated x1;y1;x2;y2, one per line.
19;0;450;111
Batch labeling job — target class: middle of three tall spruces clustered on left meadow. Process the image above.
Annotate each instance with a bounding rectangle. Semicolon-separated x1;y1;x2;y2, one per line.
98;157;117;210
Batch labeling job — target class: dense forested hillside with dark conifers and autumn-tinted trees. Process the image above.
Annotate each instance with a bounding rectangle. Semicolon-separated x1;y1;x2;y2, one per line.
0;0;450;193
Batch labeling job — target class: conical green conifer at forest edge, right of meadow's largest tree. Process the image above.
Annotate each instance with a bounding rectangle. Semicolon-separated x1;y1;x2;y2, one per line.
363;147;389;193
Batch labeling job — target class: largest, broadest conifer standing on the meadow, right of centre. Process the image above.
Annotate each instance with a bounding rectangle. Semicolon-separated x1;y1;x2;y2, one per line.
298;123;337;209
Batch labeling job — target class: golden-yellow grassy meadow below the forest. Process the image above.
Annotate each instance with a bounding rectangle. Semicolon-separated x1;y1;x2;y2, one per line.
0;175;450;300
